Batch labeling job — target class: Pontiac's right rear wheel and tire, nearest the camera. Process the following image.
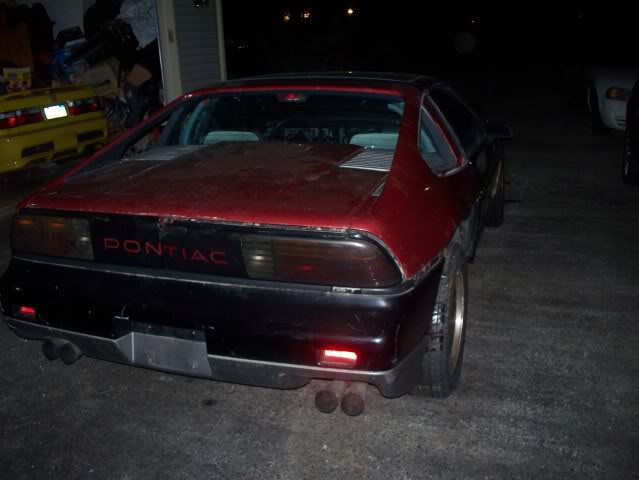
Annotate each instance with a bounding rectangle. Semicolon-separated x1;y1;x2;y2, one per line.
412;246;468;398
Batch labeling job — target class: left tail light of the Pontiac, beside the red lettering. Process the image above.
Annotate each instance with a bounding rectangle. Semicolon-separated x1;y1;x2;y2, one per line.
11;215;93;260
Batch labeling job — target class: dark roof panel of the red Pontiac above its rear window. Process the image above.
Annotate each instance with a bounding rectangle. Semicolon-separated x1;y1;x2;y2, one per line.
221;71;442;89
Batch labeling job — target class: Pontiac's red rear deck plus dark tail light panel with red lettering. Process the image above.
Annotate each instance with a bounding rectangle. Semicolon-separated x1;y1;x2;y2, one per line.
13;142;400;287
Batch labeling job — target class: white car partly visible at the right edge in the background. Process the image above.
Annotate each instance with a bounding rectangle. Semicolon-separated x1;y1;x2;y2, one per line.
588;67;639;134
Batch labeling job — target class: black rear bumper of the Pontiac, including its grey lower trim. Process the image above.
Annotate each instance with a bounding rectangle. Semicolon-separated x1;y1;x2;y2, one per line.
0;255;441;396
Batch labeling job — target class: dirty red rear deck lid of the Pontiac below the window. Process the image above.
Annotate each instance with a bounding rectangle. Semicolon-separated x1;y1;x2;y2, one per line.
23;142;386;228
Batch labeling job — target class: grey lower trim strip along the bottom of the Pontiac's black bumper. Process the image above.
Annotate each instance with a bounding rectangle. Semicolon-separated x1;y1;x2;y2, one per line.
5;317;425;397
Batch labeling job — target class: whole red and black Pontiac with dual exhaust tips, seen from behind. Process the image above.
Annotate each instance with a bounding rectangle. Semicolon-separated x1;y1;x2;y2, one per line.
0;73;511;414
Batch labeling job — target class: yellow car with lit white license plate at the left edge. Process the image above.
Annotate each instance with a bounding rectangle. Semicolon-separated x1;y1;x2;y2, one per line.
0;85;109;173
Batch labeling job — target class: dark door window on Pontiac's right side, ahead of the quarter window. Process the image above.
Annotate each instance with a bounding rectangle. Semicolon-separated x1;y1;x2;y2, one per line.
430;88;486;157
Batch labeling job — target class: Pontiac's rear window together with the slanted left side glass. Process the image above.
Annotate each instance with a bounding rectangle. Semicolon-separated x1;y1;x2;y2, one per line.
74;90;404;176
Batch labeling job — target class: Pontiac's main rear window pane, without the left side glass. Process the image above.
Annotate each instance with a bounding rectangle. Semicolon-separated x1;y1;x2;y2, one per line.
168;91;404;150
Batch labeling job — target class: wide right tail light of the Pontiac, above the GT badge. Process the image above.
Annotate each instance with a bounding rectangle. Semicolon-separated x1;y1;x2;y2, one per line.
242;235;401;288
